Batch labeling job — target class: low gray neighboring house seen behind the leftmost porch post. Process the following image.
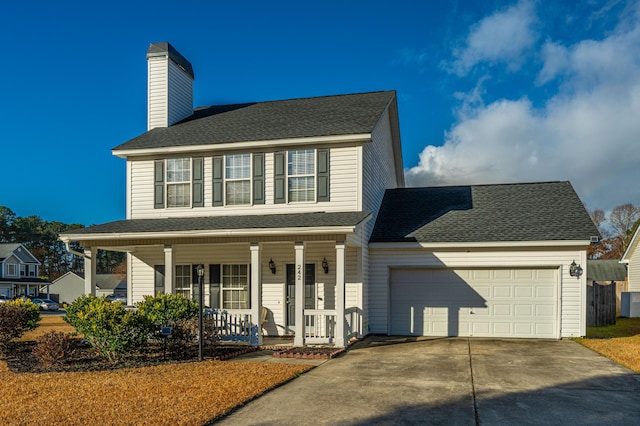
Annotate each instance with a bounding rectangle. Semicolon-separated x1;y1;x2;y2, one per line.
51;272;127;303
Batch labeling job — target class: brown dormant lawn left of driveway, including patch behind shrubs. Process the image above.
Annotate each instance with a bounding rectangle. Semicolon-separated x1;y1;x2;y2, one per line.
0;316;312;425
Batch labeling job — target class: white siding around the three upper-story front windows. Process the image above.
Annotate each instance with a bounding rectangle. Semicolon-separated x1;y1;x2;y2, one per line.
128;146;359;219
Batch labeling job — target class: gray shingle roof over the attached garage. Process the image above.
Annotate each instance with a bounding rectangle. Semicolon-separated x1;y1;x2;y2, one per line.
370;182;600;243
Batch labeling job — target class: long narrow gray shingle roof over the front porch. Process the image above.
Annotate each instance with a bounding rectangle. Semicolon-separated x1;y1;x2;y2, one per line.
61;212;370;235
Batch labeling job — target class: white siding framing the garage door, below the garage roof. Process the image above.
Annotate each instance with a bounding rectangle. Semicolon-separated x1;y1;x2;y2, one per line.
368;248;586;337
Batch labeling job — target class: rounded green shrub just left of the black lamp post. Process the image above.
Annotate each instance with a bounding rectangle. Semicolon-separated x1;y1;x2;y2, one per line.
136;294;198;351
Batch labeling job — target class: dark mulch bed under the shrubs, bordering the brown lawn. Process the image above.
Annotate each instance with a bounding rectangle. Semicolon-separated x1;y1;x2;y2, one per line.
0;339;258;373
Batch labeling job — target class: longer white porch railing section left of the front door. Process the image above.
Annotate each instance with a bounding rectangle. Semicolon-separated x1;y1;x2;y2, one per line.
204;309;258;344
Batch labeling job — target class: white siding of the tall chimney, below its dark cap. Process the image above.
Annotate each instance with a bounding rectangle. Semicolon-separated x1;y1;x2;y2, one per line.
147;57;193;130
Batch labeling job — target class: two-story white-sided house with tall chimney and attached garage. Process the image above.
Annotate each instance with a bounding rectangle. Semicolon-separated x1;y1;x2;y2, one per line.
61;43;598;346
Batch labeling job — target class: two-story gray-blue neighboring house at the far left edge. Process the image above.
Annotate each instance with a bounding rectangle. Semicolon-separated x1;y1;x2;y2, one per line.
0;243;51;298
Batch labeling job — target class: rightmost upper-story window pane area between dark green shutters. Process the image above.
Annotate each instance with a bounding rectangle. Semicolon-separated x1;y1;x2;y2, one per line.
287;149;316;203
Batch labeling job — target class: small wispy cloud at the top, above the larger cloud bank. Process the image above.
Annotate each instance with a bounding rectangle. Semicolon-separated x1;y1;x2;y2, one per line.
445;0;538;75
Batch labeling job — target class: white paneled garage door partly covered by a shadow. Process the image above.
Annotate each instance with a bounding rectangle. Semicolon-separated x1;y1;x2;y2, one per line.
390;269;558;338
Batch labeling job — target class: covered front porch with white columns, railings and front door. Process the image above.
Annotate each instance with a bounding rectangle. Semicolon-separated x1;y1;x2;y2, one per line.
62;214;367;347
